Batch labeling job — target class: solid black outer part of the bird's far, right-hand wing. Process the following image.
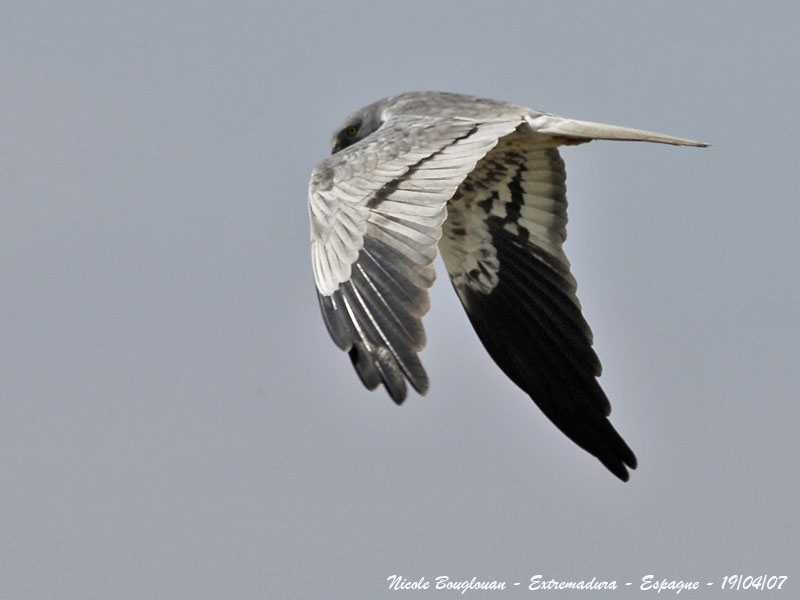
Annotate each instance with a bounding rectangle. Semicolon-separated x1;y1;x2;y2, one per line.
460;270;637;481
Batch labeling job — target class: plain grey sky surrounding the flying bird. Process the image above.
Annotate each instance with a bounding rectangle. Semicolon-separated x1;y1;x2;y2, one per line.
0;2;800;600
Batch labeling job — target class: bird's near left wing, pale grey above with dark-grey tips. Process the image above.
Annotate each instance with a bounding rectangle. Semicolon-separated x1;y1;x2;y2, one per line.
309;116;520;403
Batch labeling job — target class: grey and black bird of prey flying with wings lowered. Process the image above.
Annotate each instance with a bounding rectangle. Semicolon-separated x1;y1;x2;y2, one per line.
308;92;707;481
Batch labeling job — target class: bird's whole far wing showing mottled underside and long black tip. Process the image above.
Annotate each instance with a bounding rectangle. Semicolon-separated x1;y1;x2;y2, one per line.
439;124;636;480
